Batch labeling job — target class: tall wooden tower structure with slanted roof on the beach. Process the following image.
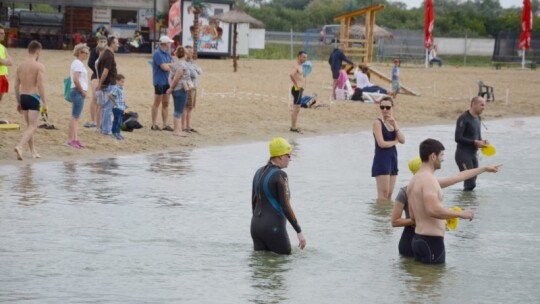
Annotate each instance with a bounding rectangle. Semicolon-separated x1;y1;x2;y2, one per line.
334;4;418;96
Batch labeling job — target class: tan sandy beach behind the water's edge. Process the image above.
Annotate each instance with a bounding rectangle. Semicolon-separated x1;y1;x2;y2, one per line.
0;49;540;164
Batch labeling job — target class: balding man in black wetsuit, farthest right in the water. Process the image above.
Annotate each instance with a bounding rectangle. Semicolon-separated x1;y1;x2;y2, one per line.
455;96;489;191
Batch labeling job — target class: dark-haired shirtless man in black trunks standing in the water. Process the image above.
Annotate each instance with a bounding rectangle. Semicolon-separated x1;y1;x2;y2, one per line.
407;138;474;264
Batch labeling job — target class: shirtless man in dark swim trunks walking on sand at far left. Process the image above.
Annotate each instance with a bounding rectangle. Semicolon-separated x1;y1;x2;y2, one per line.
15;40;47;160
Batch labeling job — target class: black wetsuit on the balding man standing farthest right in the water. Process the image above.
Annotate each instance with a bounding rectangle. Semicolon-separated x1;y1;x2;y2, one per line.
455;111;482;191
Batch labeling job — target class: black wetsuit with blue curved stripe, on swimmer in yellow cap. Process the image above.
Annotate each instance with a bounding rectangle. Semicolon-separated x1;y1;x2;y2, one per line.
251;163;302;254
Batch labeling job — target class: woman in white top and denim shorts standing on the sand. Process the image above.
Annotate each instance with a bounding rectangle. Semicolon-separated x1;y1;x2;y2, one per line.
67;43;90;149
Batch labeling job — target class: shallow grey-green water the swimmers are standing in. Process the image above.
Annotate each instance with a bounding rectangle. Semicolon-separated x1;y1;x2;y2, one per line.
0;118;540;303
